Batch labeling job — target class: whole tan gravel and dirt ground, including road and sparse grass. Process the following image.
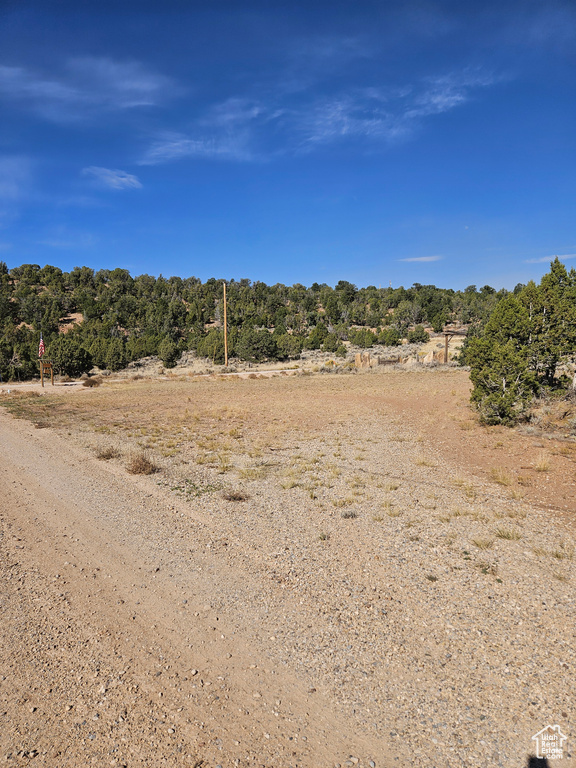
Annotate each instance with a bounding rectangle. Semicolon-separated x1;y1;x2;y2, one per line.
0;368;576;768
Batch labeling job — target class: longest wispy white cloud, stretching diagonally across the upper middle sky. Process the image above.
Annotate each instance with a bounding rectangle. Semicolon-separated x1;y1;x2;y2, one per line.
140;65;496;165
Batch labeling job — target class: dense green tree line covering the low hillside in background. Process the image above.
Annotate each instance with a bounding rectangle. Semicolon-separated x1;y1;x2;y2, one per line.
0;262;508;381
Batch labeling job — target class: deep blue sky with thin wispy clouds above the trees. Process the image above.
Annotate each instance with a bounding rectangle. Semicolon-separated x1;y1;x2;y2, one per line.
0;0;576;288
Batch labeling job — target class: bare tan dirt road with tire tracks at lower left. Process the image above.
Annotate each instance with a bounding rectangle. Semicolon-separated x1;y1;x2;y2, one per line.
0;413;386;766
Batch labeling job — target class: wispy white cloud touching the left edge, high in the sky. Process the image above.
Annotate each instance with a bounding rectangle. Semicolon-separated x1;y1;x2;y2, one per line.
0;57;177;122
